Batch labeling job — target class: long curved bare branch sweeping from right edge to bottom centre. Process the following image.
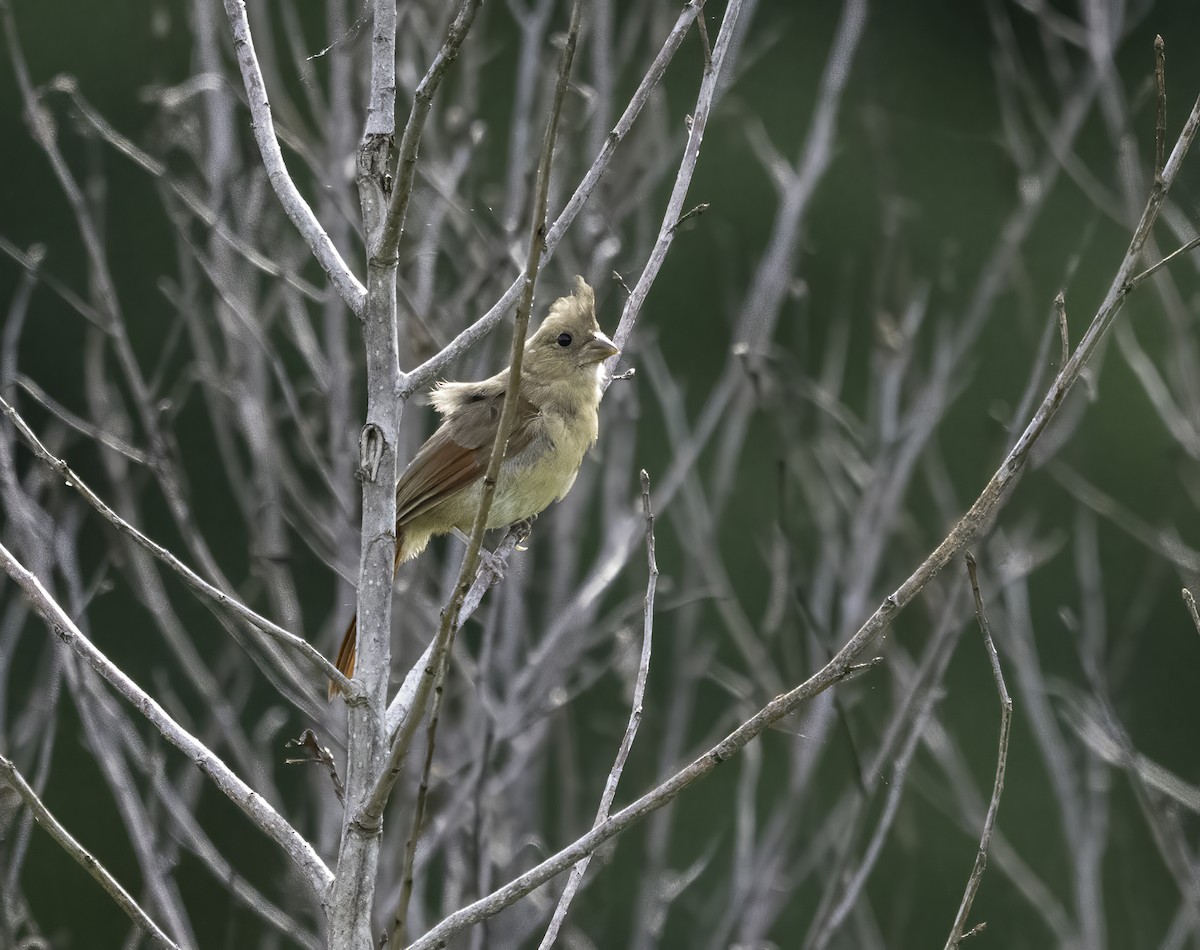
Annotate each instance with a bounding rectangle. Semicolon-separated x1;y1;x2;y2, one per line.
409;85;1200;950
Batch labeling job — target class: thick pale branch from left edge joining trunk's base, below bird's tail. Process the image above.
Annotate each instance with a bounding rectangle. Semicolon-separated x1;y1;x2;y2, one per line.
0;545;334;898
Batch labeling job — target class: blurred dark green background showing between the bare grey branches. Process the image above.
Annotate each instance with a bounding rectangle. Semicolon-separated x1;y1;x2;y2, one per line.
0;0;1200;948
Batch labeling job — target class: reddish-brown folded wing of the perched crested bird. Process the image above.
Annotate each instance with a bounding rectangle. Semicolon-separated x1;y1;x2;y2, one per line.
396;391;538;525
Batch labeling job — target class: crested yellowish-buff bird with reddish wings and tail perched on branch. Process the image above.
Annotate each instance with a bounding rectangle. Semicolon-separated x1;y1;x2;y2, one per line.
329;277;620;699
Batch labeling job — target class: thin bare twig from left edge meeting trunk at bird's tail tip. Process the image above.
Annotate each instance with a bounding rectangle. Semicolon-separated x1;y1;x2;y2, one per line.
0;388;349;686
